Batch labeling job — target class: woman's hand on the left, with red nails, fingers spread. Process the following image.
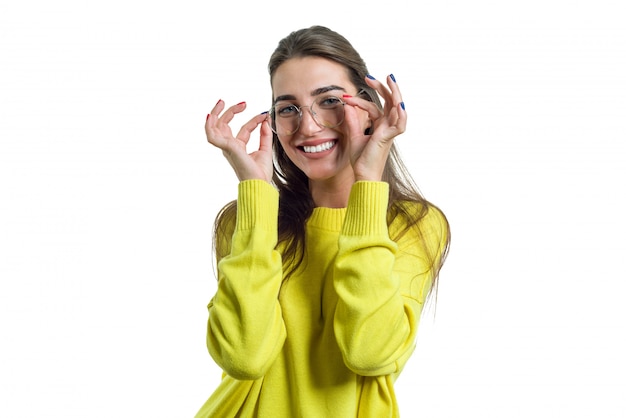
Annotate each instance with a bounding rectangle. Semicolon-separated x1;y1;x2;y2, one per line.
204;100;273;182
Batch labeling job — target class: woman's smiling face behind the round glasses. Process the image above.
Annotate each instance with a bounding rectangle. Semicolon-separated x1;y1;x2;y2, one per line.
272;57;369;180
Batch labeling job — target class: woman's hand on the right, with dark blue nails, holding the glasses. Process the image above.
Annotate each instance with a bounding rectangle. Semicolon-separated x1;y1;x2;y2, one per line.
344;75;407;181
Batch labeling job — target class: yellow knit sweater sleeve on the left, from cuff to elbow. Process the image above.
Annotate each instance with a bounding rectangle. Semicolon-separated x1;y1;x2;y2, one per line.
207;180;286;380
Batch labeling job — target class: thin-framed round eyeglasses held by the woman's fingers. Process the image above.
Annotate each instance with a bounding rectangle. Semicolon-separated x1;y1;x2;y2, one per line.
268;90;366;136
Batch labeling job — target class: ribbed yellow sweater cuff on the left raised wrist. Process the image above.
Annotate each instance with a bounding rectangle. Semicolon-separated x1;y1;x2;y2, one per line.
236;180;278;231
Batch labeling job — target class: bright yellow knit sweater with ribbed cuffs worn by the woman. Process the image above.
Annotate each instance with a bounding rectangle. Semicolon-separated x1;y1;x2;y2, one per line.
196;180;445;418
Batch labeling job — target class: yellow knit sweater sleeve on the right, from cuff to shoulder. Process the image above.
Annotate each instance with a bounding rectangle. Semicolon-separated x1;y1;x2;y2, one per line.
334;182;445;376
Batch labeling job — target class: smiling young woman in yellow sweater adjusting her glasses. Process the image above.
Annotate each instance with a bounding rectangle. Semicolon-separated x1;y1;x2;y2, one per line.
197;26;450;418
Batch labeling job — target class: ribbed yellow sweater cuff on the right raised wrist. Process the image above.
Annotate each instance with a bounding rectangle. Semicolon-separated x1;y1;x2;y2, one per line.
342;181;389;235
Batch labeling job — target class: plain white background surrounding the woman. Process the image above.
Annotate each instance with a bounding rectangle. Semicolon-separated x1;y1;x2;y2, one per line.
0;0;626;418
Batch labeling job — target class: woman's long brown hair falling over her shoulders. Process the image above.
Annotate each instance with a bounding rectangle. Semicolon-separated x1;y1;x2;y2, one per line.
213;26;450;300
